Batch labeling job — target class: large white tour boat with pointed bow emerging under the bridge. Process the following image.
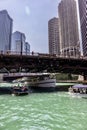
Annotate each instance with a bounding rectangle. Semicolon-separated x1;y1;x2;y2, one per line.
13;73;56;92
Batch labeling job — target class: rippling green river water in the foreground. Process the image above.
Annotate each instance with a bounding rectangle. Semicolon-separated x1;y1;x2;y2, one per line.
0;92;87;130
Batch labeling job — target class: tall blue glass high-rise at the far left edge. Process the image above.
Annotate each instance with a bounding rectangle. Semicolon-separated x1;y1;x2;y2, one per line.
0;10;13;53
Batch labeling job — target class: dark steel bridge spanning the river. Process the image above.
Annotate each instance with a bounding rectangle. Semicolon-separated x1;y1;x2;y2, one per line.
0;53;87;75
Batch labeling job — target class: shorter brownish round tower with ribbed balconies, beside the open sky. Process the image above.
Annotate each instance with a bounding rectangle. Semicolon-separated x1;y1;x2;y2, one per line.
48;17;60;55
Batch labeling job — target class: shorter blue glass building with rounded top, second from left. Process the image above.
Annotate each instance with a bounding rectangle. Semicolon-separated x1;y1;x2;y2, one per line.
11;31;26;54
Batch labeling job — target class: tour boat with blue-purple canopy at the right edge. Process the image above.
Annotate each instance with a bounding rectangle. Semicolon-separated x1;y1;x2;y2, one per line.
69;84;87;98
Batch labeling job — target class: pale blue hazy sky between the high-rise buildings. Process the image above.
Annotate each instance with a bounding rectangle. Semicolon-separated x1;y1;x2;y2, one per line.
0;0;60;53
